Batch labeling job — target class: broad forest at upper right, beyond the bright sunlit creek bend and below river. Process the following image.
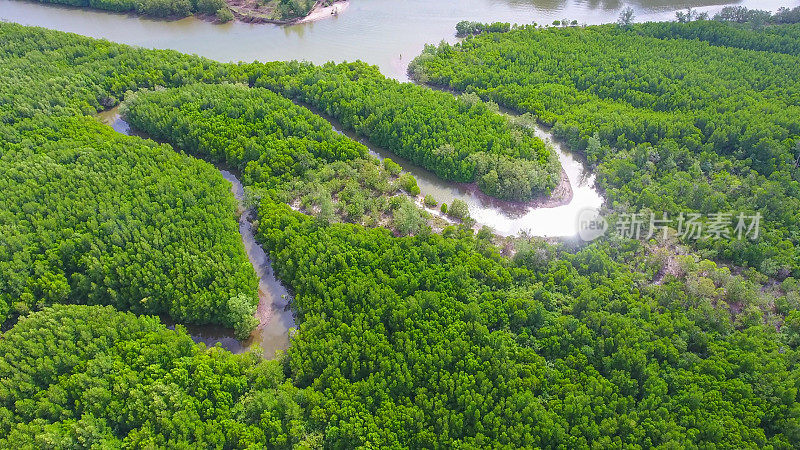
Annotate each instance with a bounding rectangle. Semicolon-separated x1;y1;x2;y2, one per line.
411;21;800;277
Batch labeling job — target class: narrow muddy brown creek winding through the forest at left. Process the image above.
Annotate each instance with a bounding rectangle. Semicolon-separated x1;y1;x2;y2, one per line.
97;108;295;359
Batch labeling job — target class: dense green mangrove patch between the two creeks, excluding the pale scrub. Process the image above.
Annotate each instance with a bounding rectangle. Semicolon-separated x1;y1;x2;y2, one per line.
122;84;367;188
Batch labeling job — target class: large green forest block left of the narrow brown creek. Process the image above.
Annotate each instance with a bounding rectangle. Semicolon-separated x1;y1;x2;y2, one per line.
0;24;257;334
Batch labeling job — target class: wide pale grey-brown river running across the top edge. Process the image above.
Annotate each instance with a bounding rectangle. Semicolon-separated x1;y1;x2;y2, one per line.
0;0;797;80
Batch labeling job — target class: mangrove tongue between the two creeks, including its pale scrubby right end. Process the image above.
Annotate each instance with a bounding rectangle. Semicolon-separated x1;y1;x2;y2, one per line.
122;84;450;234
